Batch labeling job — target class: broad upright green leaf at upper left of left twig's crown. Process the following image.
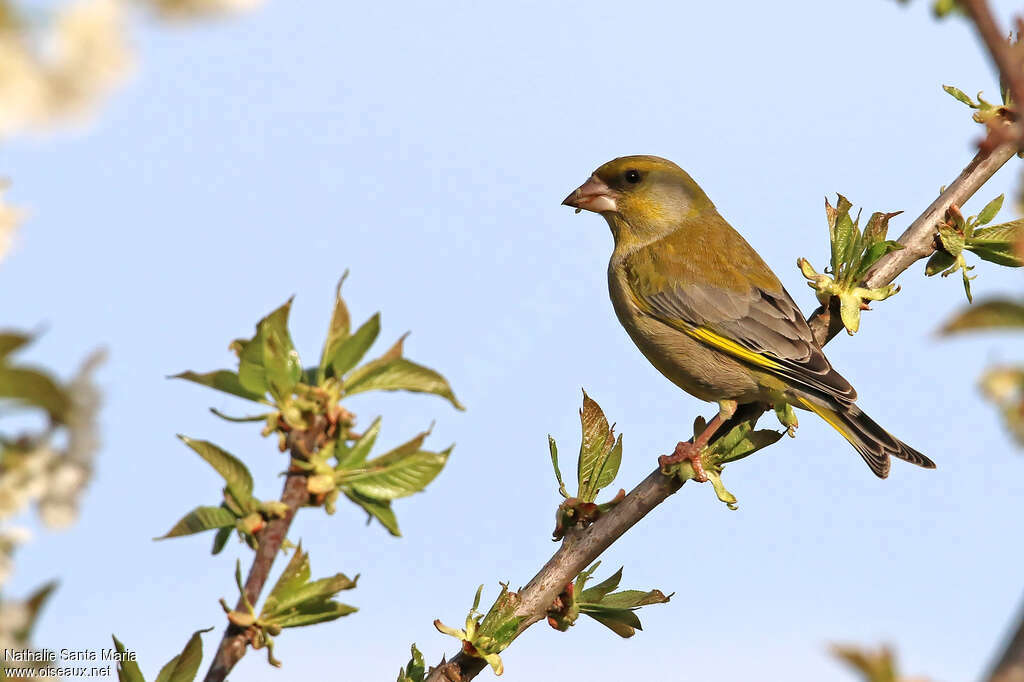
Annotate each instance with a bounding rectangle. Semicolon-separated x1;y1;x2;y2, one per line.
239;299;302;402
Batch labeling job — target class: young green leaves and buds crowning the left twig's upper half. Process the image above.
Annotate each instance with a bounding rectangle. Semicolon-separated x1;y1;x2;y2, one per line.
165;278;463;540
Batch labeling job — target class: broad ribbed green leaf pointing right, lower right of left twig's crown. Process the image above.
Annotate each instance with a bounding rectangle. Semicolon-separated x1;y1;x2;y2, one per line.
338;447;452;501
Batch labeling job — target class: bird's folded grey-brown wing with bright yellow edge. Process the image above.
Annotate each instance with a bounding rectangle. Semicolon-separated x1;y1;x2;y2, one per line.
626;228;857;402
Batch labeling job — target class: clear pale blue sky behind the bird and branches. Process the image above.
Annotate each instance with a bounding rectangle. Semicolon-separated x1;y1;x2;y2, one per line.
0;0;1024;682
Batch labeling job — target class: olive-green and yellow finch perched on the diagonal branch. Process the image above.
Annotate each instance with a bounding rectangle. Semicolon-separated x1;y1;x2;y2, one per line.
562;156;935;479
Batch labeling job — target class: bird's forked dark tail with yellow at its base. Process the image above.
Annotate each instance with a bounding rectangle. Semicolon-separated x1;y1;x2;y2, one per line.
799;397;935;478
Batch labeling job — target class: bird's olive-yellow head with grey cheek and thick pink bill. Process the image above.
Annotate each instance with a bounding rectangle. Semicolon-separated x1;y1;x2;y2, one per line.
562;156;715;244
